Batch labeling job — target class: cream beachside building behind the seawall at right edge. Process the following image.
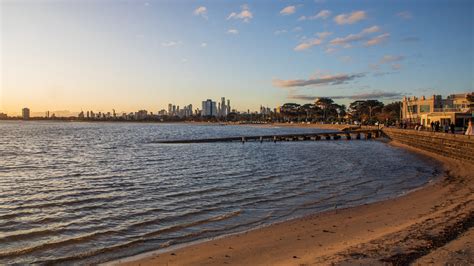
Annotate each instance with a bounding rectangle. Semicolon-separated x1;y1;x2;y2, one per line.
401;92;474;127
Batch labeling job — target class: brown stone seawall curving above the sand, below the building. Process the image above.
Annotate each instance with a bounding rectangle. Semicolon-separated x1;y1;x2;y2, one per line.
382;128;474;163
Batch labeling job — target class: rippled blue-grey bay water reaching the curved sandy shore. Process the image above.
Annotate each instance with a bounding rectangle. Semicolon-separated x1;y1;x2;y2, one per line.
0;122;437;264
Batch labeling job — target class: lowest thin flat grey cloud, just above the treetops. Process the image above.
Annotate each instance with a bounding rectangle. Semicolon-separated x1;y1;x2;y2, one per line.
288;91;406;101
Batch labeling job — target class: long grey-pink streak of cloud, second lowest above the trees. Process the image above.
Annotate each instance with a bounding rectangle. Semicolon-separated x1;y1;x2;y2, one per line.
273;73;365;88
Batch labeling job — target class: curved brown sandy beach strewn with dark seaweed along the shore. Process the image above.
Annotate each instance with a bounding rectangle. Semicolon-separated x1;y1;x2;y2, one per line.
113;140;474;265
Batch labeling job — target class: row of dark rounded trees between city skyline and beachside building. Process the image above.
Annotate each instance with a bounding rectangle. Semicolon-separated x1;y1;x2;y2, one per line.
280;98;400;124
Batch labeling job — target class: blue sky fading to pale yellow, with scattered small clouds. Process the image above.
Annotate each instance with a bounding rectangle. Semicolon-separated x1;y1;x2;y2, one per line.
0;0;474;115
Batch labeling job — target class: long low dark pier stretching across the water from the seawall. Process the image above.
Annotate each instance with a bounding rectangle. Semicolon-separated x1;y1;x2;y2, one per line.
152;129;380;144
